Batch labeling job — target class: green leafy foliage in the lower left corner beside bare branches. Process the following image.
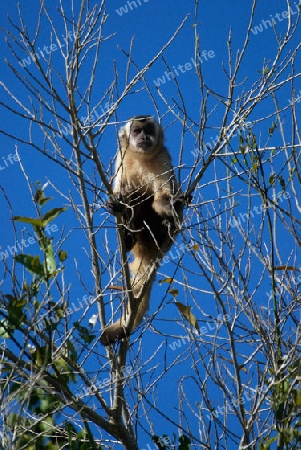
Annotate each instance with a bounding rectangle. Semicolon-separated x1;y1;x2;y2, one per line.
0;189;102;450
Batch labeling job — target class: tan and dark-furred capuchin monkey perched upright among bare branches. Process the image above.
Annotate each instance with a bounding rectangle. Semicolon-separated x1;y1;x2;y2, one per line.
100;116;185;345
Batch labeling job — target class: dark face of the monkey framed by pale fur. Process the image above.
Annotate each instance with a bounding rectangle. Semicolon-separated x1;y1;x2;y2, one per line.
130;121;158;152
